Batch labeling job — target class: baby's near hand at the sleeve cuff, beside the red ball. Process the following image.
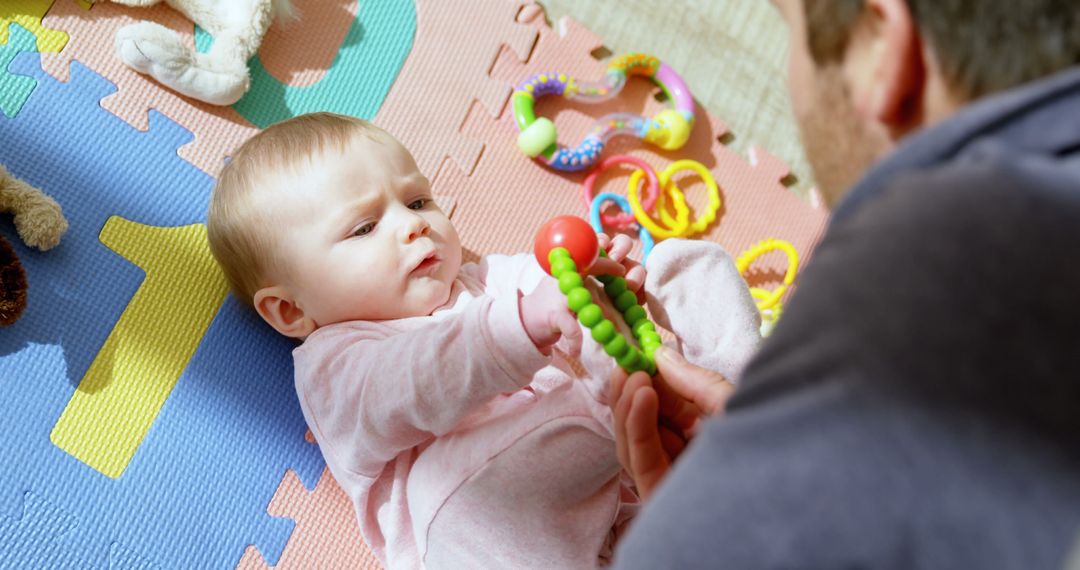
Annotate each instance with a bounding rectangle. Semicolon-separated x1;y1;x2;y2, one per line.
517;277;581;356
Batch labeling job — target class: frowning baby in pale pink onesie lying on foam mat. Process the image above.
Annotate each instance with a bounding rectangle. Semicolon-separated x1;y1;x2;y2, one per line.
207;113;758;569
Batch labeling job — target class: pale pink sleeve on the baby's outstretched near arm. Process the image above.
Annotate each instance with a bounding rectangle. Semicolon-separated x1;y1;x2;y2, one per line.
294;295;549;477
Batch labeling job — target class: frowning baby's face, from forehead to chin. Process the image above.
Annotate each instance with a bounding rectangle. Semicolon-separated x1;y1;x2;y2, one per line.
269;135;461;326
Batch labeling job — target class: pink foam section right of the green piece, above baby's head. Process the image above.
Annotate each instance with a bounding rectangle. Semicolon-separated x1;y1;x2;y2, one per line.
375;0;537;176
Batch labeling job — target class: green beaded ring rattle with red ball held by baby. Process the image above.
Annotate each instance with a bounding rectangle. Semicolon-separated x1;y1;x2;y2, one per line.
534;216;661;376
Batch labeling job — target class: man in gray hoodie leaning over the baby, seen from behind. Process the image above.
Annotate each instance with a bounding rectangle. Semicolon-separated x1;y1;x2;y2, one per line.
613;0;1080;569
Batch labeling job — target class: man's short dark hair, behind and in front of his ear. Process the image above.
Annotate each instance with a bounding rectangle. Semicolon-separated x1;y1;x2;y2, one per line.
805;0;1080;99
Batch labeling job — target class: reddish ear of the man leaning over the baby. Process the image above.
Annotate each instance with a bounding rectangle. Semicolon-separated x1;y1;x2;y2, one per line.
848;0;926;127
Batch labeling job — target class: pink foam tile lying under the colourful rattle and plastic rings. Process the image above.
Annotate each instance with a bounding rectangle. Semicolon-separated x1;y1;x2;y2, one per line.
427;13;827;297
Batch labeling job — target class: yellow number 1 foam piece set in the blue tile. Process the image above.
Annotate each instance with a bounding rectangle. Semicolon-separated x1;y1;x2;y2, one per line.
51;216;228;478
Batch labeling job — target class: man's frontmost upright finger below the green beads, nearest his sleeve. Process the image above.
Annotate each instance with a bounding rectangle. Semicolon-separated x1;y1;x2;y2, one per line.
626;388;671;500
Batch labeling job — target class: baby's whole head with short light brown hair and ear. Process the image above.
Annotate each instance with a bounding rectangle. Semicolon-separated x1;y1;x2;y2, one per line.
207;113;461;338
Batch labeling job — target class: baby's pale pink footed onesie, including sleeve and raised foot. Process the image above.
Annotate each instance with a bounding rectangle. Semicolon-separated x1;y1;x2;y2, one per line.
293;240;758;569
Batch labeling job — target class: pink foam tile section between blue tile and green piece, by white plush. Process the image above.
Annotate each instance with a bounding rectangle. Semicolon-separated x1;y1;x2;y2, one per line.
41;0;258;176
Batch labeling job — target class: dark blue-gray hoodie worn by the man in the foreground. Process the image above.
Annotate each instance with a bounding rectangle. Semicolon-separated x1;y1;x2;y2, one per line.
616;68;1080;570
